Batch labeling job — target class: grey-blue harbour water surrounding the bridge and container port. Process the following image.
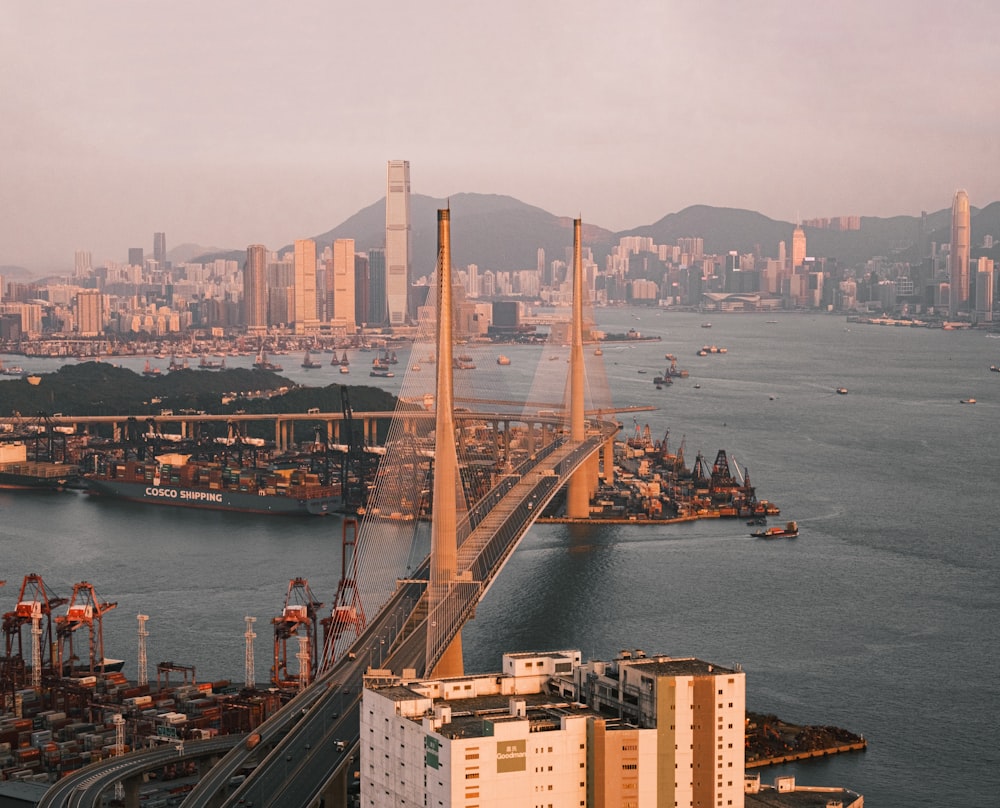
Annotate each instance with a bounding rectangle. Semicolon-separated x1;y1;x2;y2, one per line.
0;308;1000;808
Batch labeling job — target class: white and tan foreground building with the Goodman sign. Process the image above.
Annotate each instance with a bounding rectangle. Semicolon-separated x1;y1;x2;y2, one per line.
361;651;746;808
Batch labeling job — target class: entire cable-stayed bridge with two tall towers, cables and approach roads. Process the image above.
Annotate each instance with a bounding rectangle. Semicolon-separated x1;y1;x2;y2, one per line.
40;216;619;808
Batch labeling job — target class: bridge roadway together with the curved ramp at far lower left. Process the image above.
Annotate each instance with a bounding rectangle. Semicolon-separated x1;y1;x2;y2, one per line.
39;422;618;808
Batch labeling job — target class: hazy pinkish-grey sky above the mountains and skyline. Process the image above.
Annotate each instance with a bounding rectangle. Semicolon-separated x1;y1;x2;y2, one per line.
0;0;1000;270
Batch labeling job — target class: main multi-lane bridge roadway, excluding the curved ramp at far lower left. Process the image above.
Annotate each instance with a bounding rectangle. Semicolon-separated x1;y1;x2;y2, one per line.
194;424;617;808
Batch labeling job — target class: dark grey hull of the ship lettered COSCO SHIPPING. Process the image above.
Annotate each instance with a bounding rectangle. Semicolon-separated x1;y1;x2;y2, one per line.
86;478;341;516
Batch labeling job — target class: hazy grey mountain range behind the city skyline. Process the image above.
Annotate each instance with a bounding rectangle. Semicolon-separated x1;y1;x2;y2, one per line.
182;193;1000;277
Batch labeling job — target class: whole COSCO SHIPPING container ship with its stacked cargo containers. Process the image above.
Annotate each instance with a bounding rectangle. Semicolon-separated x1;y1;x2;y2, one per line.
84;454;342;516
